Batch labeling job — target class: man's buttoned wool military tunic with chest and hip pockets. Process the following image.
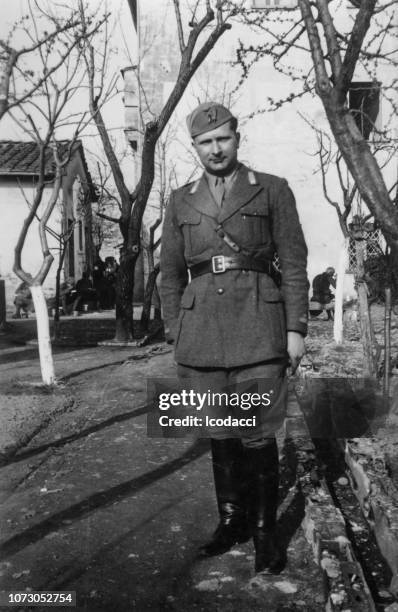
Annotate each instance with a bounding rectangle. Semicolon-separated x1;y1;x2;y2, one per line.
160;164;308;368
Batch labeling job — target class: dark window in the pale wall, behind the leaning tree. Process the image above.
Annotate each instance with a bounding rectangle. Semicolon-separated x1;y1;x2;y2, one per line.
348;81;381;140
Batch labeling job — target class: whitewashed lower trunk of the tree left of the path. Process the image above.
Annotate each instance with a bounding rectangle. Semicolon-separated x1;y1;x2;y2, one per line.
30;285;55;385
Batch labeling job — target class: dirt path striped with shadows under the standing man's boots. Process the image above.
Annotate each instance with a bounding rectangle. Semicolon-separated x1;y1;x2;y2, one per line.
0;347;324;612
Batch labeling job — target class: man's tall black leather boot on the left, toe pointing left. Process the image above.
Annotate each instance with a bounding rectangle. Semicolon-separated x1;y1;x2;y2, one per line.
200;438;250;556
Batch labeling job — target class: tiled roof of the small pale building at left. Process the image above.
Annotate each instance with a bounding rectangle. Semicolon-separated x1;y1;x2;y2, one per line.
0;140;97;201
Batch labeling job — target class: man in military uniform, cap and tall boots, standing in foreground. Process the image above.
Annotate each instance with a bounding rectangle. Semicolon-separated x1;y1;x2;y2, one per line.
161;102;308;573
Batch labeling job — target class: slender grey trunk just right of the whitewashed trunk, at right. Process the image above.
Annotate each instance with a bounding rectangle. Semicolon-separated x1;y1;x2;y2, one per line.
355;240;376;378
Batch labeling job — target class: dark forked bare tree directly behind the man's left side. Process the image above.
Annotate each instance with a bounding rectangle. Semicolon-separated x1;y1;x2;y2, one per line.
80;0;236;342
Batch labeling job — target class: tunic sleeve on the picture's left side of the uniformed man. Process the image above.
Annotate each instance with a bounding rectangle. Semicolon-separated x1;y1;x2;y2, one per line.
160;194;188;343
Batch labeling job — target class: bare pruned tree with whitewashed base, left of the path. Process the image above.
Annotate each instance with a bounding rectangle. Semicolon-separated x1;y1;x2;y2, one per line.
7;3;106;385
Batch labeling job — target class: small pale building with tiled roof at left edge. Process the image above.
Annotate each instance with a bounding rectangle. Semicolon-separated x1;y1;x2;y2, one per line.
0;140;97;308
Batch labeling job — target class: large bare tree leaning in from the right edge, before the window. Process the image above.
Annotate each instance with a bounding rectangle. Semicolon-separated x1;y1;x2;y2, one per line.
238;0;398;304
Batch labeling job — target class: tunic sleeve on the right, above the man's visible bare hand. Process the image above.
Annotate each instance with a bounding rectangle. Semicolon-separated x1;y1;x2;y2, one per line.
272;179;309;335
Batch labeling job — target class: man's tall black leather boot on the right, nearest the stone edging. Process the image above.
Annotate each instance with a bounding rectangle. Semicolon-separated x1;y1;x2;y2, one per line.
244;440;285;574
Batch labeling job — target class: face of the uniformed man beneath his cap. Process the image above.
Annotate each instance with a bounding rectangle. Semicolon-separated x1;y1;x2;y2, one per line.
192;122;240;176
